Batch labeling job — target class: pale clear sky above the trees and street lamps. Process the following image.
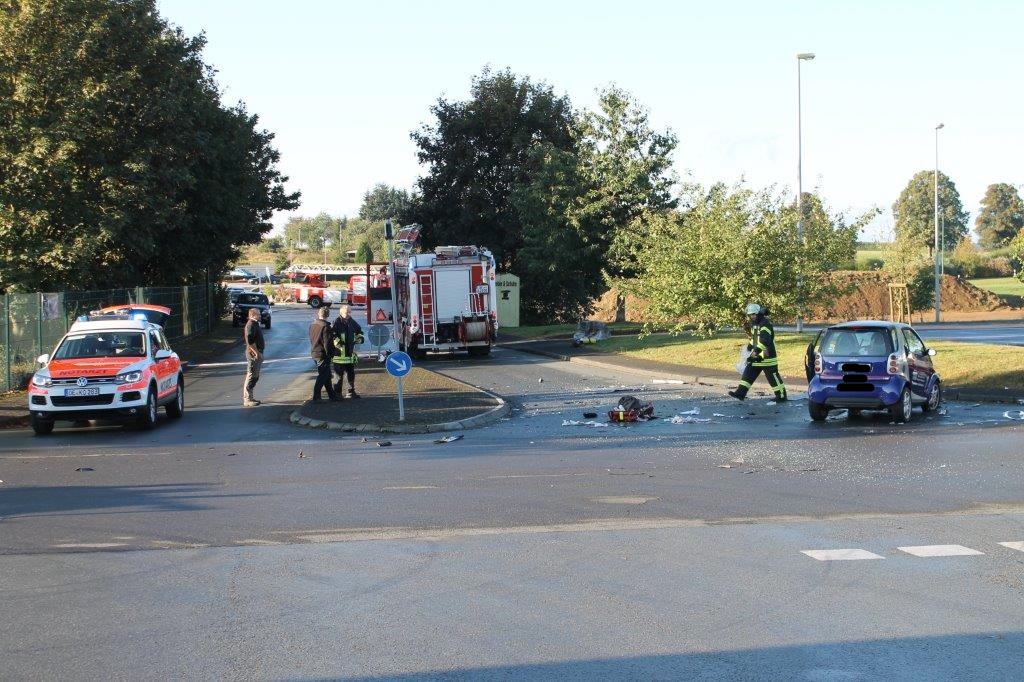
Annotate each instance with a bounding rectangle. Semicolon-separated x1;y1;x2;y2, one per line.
158;0;1024;238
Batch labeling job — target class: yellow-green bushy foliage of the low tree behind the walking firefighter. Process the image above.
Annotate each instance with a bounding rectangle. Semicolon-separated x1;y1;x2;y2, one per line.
624;184;874;333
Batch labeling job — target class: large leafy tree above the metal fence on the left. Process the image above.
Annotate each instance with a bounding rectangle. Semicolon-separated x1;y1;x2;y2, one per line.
0;0;298;290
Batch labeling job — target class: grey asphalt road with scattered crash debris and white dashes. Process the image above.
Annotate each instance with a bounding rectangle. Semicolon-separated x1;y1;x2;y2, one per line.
0;309;1024;680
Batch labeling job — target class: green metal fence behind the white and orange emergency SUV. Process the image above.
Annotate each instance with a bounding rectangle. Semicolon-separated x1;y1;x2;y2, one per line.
0;285;218;393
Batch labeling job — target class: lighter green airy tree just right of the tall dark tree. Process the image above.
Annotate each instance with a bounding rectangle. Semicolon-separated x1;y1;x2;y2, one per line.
580;87;679;278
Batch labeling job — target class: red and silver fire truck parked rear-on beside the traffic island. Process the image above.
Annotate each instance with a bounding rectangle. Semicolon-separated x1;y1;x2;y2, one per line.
387;225;498;357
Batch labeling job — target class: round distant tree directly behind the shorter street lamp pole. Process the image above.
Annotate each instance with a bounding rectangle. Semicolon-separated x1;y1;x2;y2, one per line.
893;171;970;253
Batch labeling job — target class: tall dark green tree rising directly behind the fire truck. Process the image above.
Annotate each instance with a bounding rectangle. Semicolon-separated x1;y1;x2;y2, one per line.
403;69;575;272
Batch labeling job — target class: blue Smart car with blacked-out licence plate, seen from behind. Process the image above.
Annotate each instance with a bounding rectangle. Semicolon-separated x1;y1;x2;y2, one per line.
805;319;942;422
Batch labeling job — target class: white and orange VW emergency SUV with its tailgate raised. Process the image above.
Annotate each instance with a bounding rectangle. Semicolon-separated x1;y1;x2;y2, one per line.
29;305;185;435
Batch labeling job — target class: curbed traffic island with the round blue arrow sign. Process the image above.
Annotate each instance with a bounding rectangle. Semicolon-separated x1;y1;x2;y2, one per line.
291;364;510;433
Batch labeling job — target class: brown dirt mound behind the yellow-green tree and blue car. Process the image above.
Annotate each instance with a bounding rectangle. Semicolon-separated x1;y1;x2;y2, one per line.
591;270;1018;323
